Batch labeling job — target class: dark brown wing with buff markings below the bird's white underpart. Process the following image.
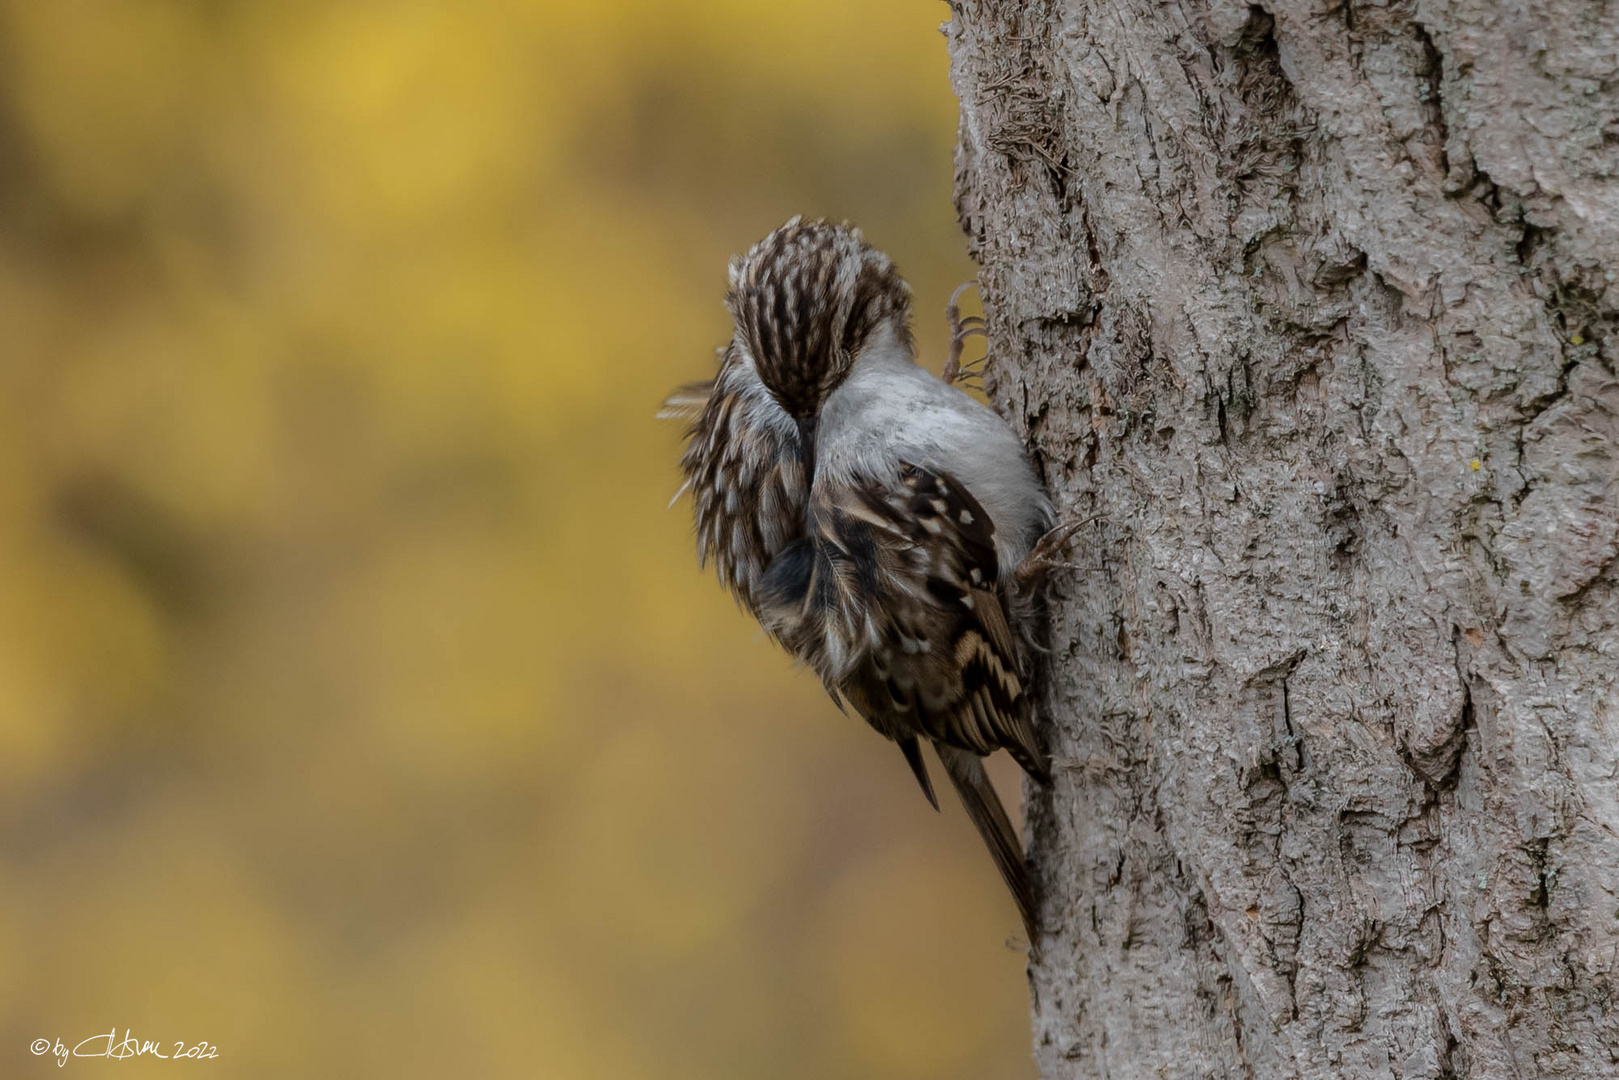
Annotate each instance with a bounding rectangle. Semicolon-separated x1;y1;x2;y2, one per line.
761;463;1049;780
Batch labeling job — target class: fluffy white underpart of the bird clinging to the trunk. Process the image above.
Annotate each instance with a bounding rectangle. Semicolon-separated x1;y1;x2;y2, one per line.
814;324;1051;573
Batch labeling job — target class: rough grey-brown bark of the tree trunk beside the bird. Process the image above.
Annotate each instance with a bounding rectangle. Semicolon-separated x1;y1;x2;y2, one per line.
947;0;1619;1080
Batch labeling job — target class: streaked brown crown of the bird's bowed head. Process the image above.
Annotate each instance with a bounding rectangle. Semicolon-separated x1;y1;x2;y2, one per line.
725;217;910;419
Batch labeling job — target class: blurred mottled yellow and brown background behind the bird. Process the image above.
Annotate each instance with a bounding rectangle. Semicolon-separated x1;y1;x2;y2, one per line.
0;0;1033;1080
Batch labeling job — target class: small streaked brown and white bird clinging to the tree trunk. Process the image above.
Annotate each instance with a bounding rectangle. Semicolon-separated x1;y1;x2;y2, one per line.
661;217;1067;942
